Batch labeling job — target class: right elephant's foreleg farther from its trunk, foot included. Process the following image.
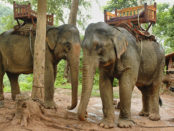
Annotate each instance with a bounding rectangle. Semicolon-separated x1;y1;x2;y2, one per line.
118;71;136;128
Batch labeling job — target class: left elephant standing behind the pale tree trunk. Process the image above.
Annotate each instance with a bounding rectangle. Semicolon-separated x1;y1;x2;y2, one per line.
0;24;81;109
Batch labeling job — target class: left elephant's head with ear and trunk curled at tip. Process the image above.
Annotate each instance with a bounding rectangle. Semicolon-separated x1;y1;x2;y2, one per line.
46;24;81;109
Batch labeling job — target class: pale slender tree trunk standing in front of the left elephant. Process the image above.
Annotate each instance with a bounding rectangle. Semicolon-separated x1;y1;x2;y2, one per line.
31;0;47;100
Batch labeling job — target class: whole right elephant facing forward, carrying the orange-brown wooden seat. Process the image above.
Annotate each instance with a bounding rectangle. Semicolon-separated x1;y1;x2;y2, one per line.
77;22;165;128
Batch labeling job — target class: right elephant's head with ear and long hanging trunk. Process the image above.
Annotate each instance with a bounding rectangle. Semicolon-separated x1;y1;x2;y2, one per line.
78;22;127;120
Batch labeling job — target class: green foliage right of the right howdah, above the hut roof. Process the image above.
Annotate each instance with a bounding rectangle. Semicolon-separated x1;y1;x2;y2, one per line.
153;4;174;53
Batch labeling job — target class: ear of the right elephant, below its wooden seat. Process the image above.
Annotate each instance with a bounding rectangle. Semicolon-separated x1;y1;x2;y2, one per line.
112;31;128;59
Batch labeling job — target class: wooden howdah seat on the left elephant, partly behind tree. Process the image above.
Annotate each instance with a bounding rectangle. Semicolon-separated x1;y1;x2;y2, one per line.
13;1;54;26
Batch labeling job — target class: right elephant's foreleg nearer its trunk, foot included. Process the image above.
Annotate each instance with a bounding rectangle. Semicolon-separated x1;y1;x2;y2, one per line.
99;71;115;128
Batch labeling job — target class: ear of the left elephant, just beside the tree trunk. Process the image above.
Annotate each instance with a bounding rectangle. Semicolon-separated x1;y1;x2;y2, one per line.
46;29;58;50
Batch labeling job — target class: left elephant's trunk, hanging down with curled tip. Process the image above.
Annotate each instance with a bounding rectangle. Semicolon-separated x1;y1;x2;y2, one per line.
68;44;80;110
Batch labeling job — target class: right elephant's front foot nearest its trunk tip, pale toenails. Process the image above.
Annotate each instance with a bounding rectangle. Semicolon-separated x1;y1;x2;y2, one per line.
99;118;115;129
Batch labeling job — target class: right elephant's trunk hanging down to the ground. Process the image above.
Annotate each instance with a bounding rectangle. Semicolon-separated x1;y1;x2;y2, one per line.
78;52;95;120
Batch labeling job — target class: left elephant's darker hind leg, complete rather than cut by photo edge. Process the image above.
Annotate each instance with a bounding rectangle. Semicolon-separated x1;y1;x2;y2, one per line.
7;72;20;100
